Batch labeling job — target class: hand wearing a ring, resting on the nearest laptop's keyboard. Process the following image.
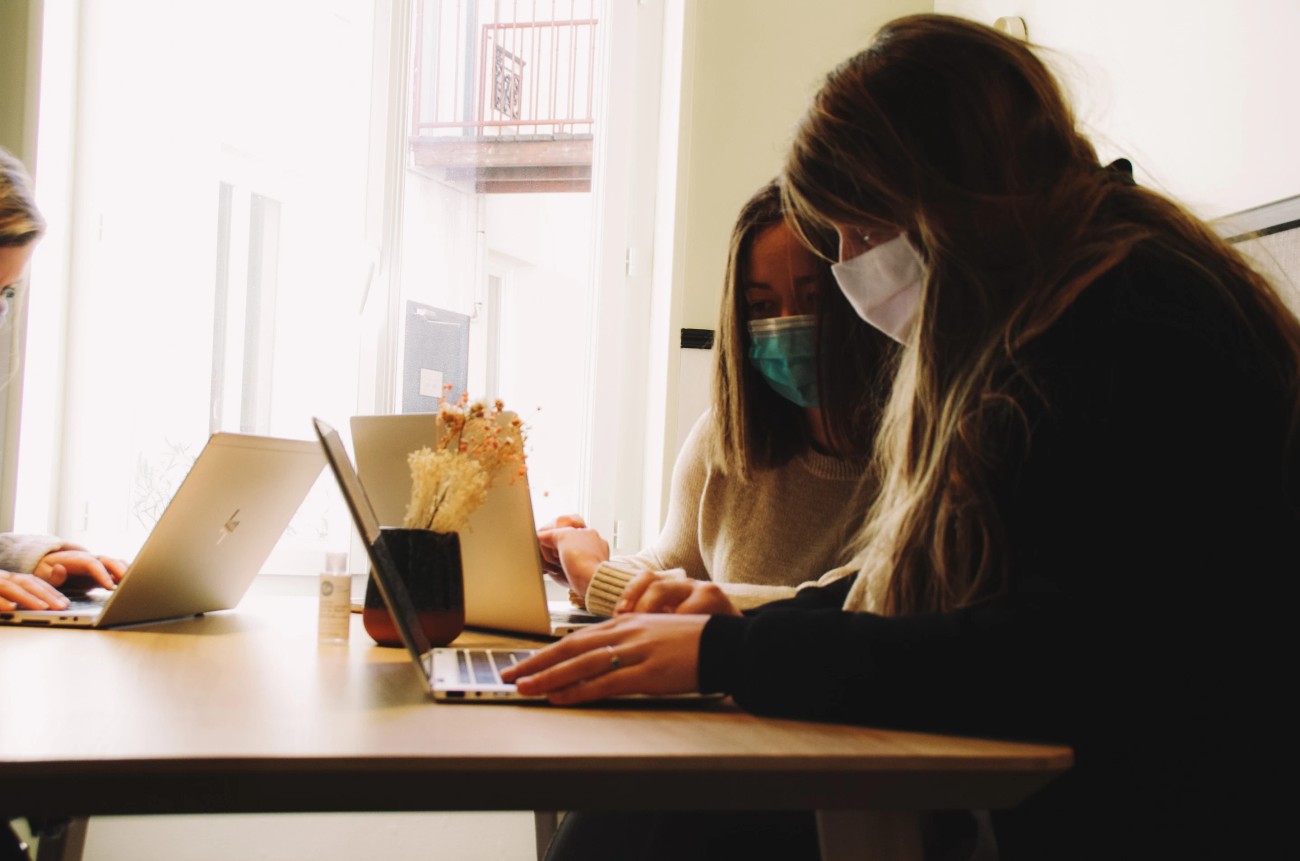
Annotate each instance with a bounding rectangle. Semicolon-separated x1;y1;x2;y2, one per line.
502;614;709;705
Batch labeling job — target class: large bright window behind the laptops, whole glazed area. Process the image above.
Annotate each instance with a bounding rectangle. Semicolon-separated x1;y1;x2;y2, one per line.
17;0;654;572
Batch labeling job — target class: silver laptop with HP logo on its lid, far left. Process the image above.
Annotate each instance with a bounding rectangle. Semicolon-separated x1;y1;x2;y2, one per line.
0;433;325;628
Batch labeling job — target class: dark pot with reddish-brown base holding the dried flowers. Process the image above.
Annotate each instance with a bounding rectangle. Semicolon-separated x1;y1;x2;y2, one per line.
361;528;465;646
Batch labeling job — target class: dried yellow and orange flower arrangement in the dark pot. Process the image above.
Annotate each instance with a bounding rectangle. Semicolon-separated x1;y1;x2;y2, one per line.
404;395;527;532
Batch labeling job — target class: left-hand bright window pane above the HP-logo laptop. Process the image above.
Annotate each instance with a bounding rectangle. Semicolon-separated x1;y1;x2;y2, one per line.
42;0;374;571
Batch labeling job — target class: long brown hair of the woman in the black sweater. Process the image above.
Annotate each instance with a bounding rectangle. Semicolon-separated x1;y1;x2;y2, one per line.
784;14;1300;621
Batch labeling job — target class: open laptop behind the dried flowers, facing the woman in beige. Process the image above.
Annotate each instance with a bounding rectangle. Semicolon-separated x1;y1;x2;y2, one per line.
351;412;602;637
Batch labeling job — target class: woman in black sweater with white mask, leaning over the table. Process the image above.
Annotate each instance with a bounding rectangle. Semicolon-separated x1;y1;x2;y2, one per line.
504;16;1300;858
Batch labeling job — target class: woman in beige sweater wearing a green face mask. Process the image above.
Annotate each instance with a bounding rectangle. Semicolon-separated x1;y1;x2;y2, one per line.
538;183;893;615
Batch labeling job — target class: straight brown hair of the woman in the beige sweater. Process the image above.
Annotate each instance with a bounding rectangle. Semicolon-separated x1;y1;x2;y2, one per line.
712;182;894;477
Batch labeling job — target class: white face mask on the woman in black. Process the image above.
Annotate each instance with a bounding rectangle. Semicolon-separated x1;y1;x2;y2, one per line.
831;234;926;343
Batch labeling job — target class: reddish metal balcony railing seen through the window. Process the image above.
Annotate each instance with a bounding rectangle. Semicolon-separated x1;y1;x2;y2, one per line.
411;0;597;139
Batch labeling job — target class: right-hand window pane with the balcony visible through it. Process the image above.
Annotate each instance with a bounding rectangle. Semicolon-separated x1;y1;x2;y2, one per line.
402;0;602;520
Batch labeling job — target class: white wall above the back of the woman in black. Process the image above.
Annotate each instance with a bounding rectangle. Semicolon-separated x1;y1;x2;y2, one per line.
935;0;1300;219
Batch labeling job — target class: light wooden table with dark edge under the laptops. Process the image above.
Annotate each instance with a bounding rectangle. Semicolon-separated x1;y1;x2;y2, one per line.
0;597;1071;858
